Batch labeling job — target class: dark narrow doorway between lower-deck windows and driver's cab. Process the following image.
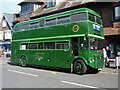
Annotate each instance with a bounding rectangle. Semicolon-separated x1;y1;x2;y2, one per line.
71;37;78;56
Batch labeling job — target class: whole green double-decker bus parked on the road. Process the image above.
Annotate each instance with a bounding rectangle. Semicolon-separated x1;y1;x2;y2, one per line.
11;8;104;74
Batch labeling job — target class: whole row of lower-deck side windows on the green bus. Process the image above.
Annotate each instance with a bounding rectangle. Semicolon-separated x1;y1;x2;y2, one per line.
20;41;69;50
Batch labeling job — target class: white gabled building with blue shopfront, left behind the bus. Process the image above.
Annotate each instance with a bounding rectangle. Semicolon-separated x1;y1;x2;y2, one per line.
0;13;13;56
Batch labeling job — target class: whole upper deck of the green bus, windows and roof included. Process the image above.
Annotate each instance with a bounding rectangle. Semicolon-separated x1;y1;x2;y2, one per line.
13;8;103;40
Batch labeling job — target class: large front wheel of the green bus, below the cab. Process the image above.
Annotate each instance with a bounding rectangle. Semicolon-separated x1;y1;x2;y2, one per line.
73;60;87;75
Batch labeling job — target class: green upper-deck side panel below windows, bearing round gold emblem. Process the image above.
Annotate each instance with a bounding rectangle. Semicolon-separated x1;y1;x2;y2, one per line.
13;21;88;40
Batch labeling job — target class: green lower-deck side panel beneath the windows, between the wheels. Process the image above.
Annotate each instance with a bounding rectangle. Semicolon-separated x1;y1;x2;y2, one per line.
18;50;72;68
